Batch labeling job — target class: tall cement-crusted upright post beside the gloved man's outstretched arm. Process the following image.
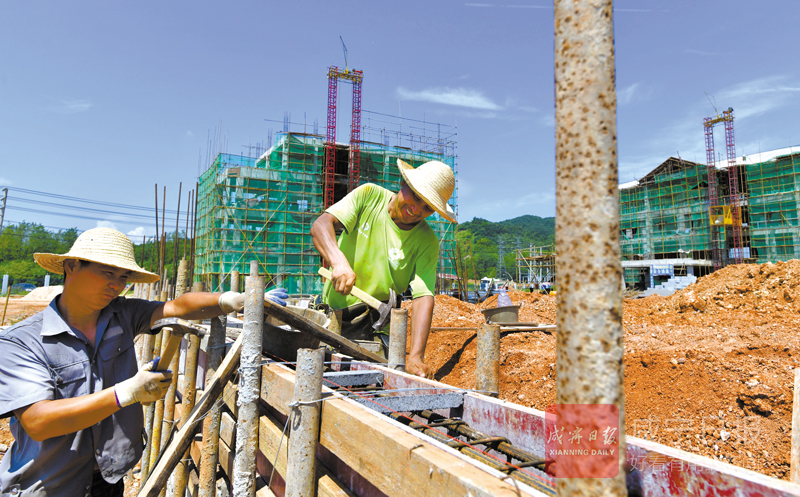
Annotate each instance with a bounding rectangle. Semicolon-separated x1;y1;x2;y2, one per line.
233;261;264;497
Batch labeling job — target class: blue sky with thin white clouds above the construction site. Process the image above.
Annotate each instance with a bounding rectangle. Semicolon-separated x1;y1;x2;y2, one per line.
0;0;800;235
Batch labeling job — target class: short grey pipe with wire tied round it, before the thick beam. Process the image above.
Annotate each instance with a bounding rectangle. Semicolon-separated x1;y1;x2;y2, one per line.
285;348;325;497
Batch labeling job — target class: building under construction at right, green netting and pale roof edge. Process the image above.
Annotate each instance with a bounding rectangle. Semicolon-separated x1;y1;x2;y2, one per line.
619;148;800;289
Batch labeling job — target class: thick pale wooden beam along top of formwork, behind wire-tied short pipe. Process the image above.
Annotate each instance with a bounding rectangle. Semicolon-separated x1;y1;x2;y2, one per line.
261;365;536;497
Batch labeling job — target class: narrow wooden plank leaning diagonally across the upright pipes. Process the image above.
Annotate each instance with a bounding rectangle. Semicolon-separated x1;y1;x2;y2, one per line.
139;337;242;497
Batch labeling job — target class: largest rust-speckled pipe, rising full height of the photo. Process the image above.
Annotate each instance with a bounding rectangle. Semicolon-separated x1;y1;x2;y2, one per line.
555;0;627;496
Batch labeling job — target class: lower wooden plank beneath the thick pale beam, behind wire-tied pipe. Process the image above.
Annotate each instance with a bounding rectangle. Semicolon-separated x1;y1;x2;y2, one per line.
258;406;355;497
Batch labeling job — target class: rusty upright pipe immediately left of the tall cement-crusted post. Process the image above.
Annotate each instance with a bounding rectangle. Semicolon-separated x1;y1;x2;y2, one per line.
197;314;227;497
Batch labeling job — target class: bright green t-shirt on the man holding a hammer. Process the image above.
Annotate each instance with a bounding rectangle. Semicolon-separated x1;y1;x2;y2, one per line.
323;183;439;309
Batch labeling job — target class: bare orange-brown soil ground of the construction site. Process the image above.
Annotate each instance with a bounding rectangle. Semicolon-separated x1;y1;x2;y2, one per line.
0;260;800;486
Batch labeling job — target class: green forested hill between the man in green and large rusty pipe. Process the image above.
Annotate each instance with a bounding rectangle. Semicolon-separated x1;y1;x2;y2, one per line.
458;215;556;277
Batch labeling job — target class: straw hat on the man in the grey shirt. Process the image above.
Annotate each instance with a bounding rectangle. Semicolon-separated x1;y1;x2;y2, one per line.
33;228;160;283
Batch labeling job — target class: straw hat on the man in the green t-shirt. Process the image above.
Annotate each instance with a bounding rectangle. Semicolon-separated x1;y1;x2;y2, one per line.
397;159;456;223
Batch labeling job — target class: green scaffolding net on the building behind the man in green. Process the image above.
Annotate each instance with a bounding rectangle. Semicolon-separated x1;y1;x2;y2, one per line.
196;133;457;295
